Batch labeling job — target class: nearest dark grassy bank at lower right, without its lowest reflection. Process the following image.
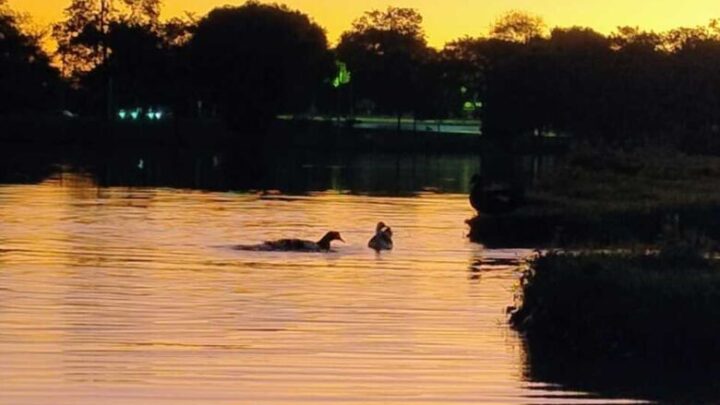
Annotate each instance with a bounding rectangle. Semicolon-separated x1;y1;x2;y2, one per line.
511;251;720;365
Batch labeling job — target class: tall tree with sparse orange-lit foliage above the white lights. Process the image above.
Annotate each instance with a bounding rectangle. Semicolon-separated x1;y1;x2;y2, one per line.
54;0;192;117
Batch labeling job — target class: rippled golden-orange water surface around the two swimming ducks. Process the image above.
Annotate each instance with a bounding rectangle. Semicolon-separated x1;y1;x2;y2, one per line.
0;153;640;405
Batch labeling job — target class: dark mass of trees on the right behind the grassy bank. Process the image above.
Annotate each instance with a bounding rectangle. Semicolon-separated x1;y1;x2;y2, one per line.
472;16;720;150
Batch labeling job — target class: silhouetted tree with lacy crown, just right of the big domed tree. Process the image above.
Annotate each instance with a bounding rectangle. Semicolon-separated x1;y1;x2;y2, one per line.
336;7;429;124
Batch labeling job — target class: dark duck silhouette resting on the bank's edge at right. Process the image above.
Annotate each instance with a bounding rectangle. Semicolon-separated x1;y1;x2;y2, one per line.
470;174;525;215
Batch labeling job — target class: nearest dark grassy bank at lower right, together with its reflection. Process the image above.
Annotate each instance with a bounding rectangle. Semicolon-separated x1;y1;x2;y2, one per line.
511;251;720;401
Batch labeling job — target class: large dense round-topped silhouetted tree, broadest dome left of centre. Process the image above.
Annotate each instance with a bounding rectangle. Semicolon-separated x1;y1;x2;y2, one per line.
187;2;334;128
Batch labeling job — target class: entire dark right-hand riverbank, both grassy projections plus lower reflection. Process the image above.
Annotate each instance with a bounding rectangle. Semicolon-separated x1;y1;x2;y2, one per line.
468;145;720;403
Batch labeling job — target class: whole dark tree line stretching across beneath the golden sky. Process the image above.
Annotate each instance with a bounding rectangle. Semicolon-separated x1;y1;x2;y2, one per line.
0;0;720;146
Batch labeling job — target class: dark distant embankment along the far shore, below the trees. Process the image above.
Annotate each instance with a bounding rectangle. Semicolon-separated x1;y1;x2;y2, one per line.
0;117;562;153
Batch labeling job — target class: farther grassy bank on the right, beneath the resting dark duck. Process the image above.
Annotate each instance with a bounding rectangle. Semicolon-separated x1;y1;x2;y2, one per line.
468;144;720;247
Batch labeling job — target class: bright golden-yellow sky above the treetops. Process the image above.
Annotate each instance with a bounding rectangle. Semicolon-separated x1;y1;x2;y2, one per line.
9;0;720;46
